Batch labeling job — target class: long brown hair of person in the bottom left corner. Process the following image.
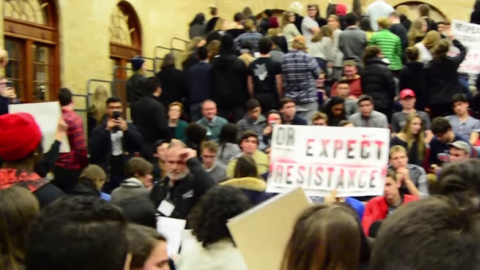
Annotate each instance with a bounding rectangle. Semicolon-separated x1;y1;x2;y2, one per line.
0;186;39;270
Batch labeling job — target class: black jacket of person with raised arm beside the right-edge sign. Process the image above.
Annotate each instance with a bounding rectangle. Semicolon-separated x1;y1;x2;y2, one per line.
425;40;467;105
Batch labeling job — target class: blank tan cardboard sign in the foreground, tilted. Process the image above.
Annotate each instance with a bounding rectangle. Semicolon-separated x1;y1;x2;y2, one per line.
227;188;311;270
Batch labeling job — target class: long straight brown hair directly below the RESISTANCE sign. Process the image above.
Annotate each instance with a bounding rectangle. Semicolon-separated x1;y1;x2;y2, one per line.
280;204;362;270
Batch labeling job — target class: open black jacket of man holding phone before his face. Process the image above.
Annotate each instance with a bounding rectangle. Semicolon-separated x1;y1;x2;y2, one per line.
88;119;143;174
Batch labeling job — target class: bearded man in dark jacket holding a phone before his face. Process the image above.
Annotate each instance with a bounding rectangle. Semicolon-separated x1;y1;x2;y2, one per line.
89;97;143;194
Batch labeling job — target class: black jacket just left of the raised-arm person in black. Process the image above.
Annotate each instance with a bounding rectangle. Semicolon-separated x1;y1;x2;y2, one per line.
399;62;427;111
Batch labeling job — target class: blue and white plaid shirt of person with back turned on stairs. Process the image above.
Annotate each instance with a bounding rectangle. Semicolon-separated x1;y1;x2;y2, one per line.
282;50;320;104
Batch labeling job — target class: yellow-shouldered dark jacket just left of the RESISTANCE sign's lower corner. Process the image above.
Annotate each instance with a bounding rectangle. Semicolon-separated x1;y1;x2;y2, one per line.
220;177;274;205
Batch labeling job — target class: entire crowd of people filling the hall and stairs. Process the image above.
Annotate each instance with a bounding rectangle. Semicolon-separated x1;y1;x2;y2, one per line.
0;0;480;270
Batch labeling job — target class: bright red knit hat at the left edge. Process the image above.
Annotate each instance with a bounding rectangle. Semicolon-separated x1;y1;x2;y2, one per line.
0;113;42;161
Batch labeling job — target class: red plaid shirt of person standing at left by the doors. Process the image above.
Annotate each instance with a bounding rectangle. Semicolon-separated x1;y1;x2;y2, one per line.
55;109;88;169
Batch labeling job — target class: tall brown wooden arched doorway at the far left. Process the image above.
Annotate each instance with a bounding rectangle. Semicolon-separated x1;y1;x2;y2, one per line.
3;0;60;102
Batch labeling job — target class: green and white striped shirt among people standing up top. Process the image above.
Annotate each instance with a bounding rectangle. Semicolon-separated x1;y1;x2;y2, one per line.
368;29;403;70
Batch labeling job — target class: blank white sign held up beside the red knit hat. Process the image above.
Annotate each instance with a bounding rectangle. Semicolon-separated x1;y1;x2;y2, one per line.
8;101;70;153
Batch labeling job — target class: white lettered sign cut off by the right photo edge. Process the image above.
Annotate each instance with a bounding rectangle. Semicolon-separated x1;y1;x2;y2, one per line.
449;20;480;74
